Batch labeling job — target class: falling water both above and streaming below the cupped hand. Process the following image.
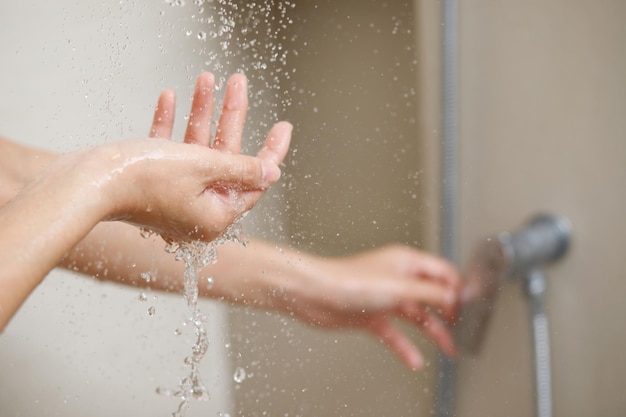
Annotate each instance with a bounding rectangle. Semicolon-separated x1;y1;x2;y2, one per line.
151;0;295;417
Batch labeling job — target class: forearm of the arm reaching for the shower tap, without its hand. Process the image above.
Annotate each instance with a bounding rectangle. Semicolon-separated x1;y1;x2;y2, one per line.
60;222;324;316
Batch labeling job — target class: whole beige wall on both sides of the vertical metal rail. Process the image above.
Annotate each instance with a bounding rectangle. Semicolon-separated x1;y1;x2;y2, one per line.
235;1;626;416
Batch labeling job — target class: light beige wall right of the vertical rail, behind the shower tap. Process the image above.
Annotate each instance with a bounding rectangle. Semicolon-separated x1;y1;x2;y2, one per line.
450;0;626;417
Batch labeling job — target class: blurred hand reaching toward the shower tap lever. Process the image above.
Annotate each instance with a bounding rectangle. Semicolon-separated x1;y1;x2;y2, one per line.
288;245;460;369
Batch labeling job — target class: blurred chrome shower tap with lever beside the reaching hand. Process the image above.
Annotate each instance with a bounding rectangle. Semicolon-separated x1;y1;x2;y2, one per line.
455;215;571;354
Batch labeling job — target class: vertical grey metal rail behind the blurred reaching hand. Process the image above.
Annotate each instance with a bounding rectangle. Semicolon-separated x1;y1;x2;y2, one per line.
435;0;459;417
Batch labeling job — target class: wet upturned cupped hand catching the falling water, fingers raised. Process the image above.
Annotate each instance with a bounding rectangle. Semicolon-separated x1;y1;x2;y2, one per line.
109;73;292;241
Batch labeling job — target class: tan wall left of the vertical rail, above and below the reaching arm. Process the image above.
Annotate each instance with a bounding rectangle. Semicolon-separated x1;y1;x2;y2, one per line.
232;0;437;417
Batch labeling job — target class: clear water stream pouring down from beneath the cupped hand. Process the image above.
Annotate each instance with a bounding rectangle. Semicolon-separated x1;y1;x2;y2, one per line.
151;220;248;417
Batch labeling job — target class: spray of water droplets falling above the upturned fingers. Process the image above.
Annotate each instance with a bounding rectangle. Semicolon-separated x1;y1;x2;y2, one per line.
163;0;297;137
